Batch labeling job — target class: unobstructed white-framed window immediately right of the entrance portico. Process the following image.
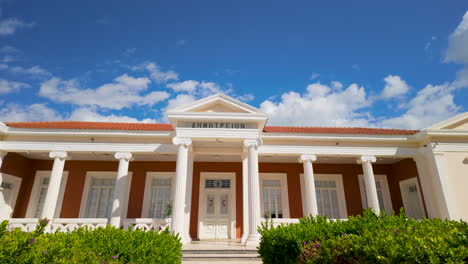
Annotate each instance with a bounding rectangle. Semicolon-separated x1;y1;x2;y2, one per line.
260;173;289;218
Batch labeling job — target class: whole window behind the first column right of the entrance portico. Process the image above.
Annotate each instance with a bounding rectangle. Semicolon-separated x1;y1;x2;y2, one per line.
301;174;348;219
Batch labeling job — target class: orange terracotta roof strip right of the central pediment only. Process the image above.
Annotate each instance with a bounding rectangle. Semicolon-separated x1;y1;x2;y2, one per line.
263;126;418;135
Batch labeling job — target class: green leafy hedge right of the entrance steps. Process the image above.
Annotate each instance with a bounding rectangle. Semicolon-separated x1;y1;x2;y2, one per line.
259;211;468;263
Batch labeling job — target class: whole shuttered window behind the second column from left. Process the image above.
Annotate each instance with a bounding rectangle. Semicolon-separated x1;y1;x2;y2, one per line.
80;171;131;218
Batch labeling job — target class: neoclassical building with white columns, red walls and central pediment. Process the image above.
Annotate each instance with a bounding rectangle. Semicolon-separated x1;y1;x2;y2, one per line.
0;94;468;245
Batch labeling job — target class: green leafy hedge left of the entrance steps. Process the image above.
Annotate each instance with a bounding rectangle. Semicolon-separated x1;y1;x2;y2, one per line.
0;220;182;264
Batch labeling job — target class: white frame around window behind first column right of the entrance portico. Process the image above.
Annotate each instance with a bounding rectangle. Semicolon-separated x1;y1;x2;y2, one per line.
300;173;348;219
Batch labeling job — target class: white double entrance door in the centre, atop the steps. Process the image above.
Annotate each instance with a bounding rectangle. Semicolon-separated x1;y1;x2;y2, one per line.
199;173;235;239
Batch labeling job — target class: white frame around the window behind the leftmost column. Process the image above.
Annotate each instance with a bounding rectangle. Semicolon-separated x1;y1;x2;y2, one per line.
26;171;68;218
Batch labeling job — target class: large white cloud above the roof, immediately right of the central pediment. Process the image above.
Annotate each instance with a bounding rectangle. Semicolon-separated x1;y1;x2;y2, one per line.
260;83;370;127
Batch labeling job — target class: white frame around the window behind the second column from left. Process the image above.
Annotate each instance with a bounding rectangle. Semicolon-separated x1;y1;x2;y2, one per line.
80;171;132;219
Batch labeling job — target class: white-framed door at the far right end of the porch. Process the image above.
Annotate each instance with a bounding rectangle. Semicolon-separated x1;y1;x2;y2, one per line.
400;177;425;219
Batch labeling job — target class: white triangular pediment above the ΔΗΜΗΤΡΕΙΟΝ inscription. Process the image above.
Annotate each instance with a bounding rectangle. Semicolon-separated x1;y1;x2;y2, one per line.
168;94;265;114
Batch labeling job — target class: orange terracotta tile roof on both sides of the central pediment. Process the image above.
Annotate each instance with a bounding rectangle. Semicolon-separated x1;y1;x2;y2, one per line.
5;121;418;135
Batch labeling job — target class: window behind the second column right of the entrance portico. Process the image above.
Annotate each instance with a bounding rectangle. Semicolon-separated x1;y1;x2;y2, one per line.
359;174;393;215
